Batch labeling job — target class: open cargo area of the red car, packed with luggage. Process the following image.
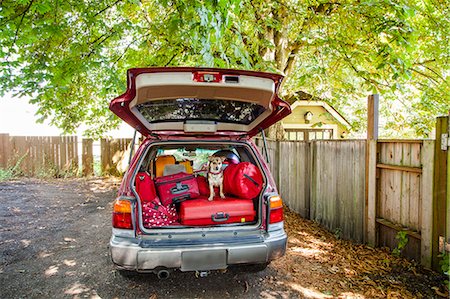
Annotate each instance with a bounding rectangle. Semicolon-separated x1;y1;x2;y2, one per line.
135;141;267;233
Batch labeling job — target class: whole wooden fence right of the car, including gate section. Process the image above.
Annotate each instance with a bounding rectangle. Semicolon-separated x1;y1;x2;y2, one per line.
255;134;444;269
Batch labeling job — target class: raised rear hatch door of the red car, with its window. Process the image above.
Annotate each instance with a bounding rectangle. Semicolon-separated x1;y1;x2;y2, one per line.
110;67;291;137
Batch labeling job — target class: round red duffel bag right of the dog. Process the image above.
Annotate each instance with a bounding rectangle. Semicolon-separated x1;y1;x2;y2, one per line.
223;162;263;199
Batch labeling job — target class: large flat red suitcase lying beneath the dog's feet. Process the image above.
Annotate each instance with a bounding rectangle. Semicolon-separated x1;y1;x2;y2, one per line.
180;198;256;226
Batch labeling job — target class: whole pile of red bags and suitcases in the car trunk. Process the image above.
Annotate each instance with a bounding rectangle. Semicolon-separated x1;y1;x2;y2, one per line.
136;158;263;228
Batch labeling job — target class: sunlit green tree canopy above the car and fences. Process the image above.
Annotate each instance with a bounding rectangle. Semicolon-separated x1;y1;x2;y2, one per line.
0;0;450;136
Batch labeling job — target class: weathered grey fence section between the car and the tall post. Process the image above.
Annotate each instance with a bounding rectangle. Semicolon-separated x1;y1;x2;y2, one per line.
256;139;366;242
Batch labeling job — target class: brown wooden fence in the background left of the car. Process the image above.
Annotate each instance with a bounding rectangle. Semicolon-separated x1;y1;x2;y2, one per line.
0;134;135;177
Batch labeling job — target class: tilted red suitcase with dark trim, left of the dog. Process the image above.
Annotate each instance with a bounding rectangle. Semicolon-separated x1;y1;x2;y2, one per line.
155;172;200;206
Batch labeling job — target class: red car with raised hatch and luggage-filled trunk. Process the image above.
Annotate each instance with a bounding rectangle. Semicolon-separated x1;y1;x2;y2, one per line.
110;67;291;278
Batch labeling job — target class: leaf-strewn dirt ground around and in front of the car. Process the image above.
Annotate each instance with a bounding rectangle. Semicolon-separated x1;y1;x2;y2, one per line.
0;179;445;299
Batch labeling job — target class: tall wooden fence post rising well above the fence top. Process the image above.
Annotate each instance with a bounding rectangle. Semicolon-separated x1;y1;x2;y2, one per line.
364;94;379;246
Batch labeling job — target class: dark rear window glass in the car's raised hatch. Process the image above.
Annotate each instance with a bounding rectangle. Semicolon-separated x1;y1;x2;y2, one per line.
136;98;265;125
